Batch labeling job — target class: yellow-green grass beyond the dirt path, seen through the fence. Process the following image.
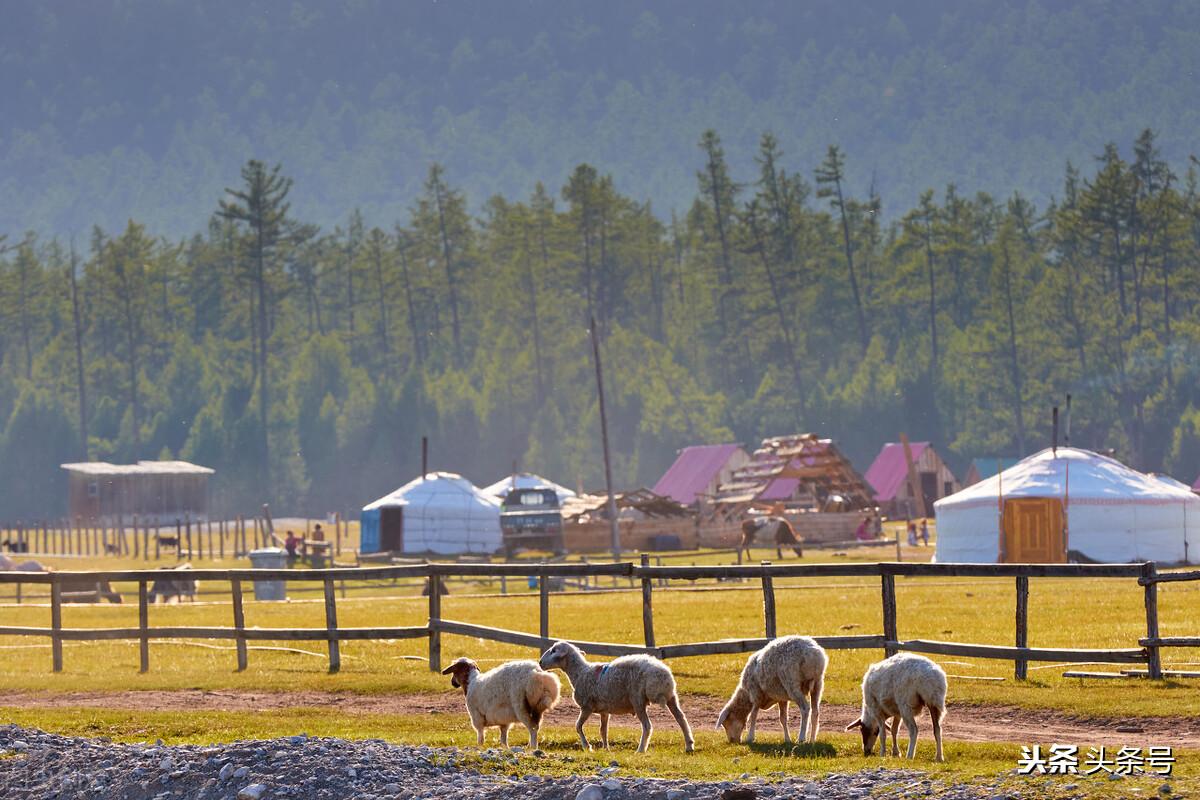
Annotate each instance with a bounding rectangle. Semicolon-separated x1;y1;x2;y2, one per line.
0;566;1200;716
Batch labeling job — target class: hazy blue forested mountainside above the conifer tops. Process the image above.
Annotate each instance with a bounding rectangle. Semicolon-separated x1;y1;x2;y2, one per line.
7;0;1200;236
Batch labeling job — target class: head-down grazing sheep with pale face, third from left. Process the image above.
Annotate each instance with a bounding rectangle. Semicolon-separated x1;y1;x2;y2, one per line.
716;636;829;745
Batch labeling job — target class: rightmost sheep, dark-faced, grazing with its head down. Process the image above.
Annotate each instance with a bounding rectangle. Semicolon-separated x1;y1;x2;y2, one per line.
846;652;946;762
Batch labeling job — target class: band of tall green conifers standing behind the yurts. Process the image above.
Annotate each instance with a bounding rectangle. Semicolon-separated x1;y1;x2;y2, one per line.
0;130;1200;517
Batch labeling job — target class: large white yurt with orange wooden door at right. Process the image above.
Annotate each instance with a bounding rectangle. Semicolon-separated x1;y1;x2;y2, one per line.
934;447;1200;564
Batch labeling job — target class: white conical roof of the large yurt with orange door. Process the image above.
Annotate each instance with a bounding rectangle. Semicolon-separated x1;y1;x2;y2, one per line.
934;447;1196;511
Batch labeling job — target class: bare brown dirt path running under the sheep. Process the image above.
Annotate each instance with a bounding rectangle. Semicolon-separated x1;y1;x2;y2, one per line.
0;690;1200;748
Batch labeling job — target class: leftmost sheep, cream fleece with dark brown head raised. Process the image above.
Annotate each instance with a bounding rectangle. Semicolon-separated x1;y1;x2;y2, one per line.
442;658;562;750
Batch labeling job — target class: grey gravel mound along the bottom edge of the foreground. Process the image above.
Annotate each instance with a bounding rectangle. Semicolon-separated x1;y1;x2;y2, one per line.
0;726;1003;800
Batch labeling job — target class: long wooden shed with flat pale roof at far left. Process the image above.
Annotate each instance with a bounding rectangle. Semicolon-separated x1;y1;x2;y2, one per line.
62;461;214;525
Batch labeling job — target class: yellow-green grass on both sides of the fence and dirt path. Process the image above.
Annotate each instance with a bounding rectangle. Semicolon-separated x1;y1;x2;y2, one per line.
0;545;1200;798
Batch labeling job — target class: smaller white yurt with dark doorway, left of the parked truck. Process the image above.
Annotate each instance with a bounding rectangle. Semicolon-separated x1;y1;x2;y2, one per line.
360;473;500;554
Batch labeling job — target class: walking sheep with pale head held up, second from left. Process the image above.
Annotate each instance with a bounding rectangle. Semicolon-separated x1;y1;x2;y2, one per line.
539;642;696;753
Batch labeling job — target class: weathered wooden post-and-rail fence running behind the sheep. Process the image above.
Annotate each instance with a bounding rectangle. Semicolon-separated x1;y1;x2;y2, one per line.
0;555;1185;679
